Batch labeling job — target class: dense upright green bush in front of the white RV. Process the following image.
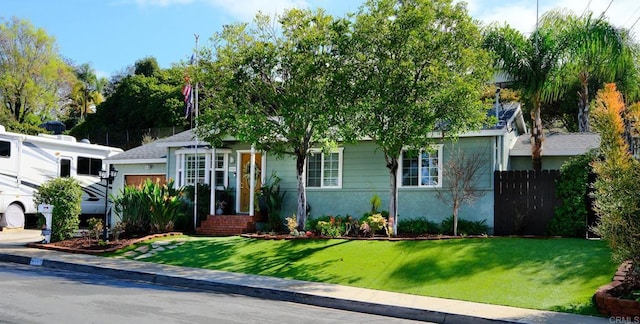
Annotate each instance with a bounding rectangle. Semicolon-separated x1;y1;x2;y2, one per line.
33;178;82;242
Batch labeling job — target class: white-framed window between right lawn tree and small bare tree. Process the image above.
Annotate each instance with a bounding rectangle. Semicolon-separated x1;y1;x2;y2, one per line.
399;145;442;188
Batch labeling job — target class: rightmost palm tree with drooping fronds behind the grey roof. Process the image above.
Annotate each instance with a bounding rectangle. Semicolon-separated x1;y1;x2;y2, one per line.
542;10;635;132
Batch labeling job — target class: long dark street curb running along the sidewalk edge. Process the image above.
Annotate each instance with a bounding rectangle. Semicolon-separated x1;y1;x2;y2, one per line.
0;253;521;324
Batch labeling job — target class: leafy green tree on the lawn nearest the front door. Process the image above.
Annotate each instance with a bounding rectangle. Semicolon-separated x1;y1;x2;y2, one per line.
194;9;349;231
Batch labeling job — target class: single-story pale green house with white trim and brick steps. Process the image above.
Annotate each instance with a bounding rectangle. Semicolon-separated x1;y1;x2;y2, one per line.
105;103;528;234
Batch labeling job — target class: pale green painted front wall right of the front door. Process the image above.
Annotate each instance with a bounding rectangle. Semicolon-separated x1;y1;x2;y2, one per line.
266;137;496;226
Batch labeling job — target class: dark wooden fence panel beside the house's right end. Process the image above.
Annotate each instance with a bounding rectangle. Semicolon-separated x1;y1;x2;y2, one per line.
493;170;560;235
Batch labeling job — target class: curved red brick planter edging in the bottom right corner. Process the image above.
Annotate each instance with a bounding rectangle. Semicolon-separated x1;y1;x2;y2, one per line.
593;261;640;317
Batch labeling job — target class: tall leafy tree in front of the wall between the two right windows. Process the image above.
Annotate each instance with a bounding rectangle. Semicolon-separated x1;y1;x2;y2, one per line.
339;0;490;234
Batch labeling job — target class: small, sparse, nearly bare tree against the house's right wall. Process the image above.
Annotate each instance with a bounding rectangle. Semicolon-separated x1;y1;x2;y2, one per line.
436;147;486;236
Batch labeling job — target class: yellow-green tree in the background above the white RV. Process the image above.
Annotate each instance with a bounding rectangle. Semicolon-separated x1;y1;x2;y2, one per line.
0;18;73;123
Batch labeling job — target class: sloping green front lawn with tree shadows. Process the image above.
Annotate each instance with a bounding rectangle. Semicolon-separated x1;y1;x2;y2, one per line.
110;237;617;314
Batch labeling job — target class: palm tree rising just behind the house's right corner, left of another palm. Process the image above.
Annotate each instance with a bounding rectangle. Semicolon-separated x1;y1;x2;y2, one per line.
484;25;562;171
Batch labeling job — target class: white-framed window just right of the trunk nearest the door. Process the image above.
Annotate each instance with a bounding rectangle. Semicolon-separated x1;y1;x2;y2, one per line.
305;148;344;188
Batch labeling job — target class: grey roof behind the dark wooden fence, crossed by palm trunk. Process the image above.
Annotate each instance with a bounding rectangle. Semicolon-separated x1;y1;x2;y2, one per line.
509;133;600;156
